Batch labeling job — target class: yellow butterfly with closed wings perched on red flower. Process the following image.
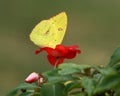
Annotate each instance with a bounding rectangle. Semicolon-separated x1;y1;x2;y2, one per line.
30;12;67;48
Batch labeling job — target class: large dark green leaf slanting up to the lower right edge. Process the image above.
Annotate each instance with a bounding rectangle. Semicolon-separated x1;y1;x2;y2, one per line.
94;74;120;93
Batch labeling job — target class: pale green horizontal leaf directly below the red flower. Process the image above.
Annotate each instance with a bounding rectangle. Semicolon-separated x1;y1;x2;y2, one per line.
58;63;90;75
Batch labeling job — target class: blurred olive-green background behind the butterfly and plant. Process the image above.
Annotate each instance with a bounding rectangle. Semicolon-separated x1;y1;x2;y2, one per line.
0;0;120;96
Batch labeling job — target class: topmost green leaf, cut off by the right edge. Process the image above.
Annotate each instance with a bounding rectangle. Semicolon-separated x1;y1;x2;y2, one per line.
109;47;120;66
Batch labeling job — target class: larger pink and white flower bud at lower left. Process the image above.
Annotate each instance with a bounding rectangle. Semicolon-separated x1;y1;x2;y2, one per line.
25;72;39;83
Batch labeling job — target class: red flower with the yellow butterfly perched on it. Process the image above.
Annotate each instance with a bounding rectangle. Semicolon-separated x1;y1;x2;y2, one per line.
36;45;81;66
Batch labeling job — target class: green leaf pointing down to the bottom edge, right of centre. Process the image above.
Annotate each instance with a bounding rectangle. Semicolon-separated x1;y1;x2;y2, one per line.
81;77;96;96
